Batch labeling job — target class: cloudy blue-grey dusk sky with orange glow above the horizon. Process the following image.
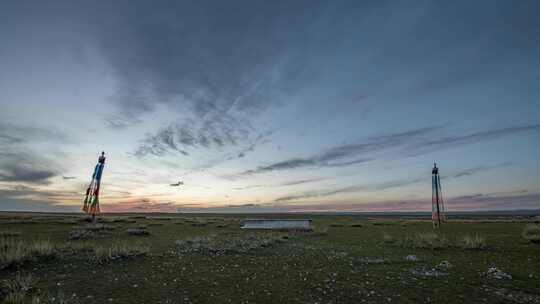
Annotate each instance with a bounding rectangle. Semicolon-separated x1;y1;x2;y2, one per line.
0;0;540;212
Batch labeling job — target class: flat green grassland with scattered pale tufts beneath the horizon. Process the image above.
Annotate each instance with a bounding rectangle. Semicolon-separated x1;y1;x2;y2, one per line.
0;213;540;303
